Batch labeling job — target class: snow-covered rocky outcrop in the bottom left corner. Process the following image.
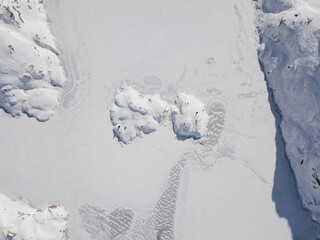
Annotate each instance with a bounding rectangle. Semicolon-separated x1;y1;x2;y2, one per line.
0;194;68;240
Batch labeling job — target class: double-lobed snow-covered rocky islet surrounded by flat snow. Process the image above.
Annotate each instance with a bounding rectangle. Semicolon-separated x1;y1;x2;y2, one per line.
110;86;209;144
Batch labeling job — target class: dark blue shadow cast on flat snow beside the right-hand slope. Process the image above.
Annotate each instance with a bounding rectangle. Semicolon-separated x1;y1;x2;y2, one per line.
268;85;318;240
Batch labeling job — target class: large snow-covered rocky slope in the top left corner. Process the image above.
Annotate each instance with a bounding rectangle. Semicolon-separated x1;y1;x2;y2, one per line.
0;0;65;121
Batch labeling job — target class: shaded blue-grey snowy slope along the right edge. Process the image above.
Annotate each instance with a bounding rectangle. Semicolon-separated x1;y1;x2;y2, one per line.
258;0;320;229
